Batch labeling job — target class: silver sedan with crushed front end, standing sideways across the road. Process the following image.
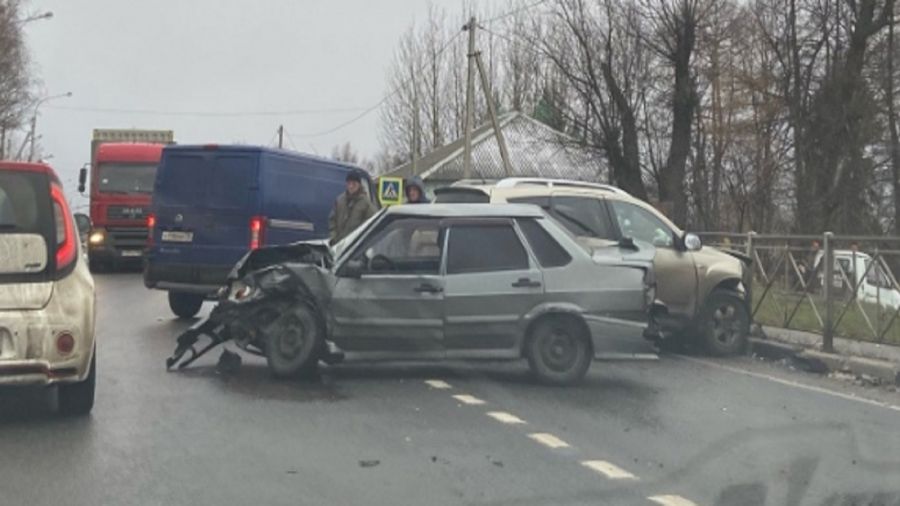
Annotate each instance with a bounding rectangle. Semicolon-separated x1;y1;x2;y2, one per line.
167;204;658;384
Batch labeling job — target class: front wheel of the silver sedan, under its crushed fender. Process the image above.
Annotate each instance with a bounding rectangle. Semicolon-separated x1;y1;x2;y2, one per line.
264;302;325;378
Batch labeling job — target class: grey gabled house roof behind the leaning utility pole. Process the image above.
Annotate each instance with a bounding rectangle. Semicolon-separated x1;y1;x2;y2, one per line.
386;112;605;181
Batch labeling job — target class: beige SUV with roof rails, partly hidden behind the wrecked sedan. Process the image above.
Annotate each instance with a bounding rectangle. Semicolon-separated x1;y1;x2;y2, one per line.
435;178;751;355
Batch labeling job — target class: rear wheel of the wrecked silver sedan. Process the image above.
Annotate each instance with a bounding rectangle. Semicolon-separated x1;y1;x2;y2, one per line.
525;316;593;386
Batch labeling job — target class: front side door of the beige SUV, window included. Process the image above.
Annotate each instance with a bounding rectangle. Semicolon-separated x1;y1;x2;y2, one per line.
607;198;705;315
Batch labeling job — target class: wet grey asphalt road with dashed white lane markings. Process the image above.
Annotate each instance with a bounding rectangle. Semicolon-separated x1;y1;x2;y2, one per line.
0;274;900;506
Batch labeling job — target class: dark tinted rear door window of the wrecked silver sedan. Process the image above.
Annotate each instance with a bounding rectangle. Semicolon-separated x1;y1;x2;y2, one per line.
447;224;528;274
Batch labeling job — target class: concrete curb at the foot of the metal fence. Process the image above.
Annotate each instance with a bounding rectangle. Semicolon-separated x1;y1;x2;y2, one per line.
750;338;900;386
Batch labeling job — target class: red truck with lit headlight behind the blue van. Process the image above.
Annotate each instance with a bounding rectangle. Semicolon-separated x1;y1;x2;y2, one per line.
78;129;174;271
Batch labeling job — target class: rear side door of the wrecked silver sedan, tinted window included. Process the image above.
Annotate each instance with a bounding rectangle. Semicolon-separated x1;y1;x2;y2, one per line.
444;219;543;357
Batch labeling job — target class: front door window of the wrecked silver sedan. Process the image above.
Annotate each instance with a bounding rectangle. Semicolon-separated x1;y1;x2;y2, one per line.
354;218;443;274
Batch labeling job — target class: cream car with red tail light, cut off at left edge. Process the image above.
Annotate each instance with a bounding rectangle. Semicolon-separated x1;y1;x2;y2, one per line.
0;161;97;415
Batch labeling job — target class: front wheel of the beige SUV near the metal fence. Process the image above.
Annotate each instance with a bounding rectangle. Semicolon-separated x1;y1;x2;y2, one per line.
697;290;750;357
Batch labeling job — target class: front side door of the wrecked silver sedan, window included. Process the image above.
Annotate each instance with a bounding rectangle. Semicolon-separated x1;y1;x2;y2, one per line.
330;216;444;355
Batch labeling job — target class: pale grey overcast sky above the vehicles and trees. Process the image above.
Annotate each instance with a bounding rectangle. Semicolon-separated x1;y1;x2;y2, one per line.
26;0;507;198
